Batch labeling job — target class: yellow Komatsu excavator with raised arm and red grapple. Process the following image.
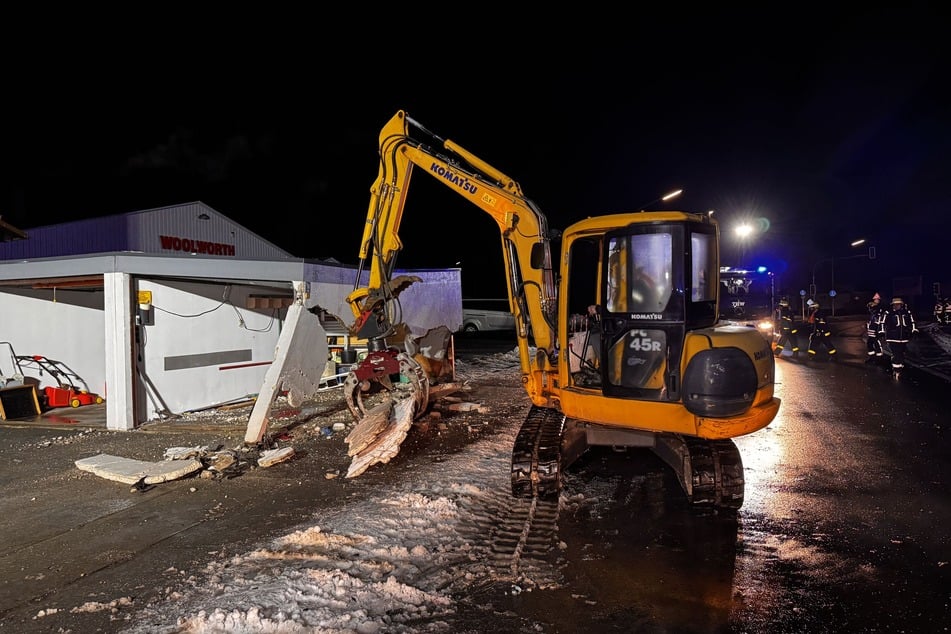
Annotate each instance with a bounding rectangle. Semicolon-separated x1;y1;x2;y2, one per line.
344;110;780;510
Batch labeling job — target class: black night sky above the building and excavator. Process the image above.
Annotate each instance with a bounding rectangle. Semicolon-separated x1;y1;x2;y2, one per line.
0;4;951;296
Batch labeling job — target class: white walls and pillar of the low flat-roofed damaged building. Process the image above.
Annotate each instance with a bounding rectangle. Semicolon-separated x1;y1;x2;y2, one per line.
0;254;462;429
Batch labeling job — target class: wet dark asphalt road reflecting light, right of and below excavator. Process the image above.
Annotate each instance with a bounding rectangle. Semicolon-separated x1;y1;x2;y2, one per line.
490;324;951;634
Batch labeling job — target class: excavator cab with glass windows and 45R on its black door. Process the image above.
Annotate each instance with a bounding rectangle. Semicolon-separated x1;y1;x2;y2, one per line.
567;213;718;401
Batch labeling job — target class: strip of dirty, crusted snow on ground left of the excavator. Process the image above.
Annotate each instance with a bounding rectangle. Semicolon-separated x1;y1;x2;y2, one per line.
127;352;558;634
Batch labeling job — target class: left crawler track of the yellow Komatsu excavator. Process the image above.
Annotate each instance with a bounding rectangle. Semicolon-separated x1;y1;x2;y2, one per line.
512;405;566;498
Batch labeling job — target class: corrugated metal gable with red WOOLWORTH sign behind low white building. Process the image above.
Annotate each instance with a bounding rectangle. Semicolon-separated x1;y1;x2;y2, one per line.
0;202;297;260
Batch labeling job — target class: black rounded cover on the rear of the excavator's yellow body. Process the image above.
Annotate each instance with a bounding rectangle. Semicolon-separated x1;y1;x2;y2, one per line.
683;347;758;418
